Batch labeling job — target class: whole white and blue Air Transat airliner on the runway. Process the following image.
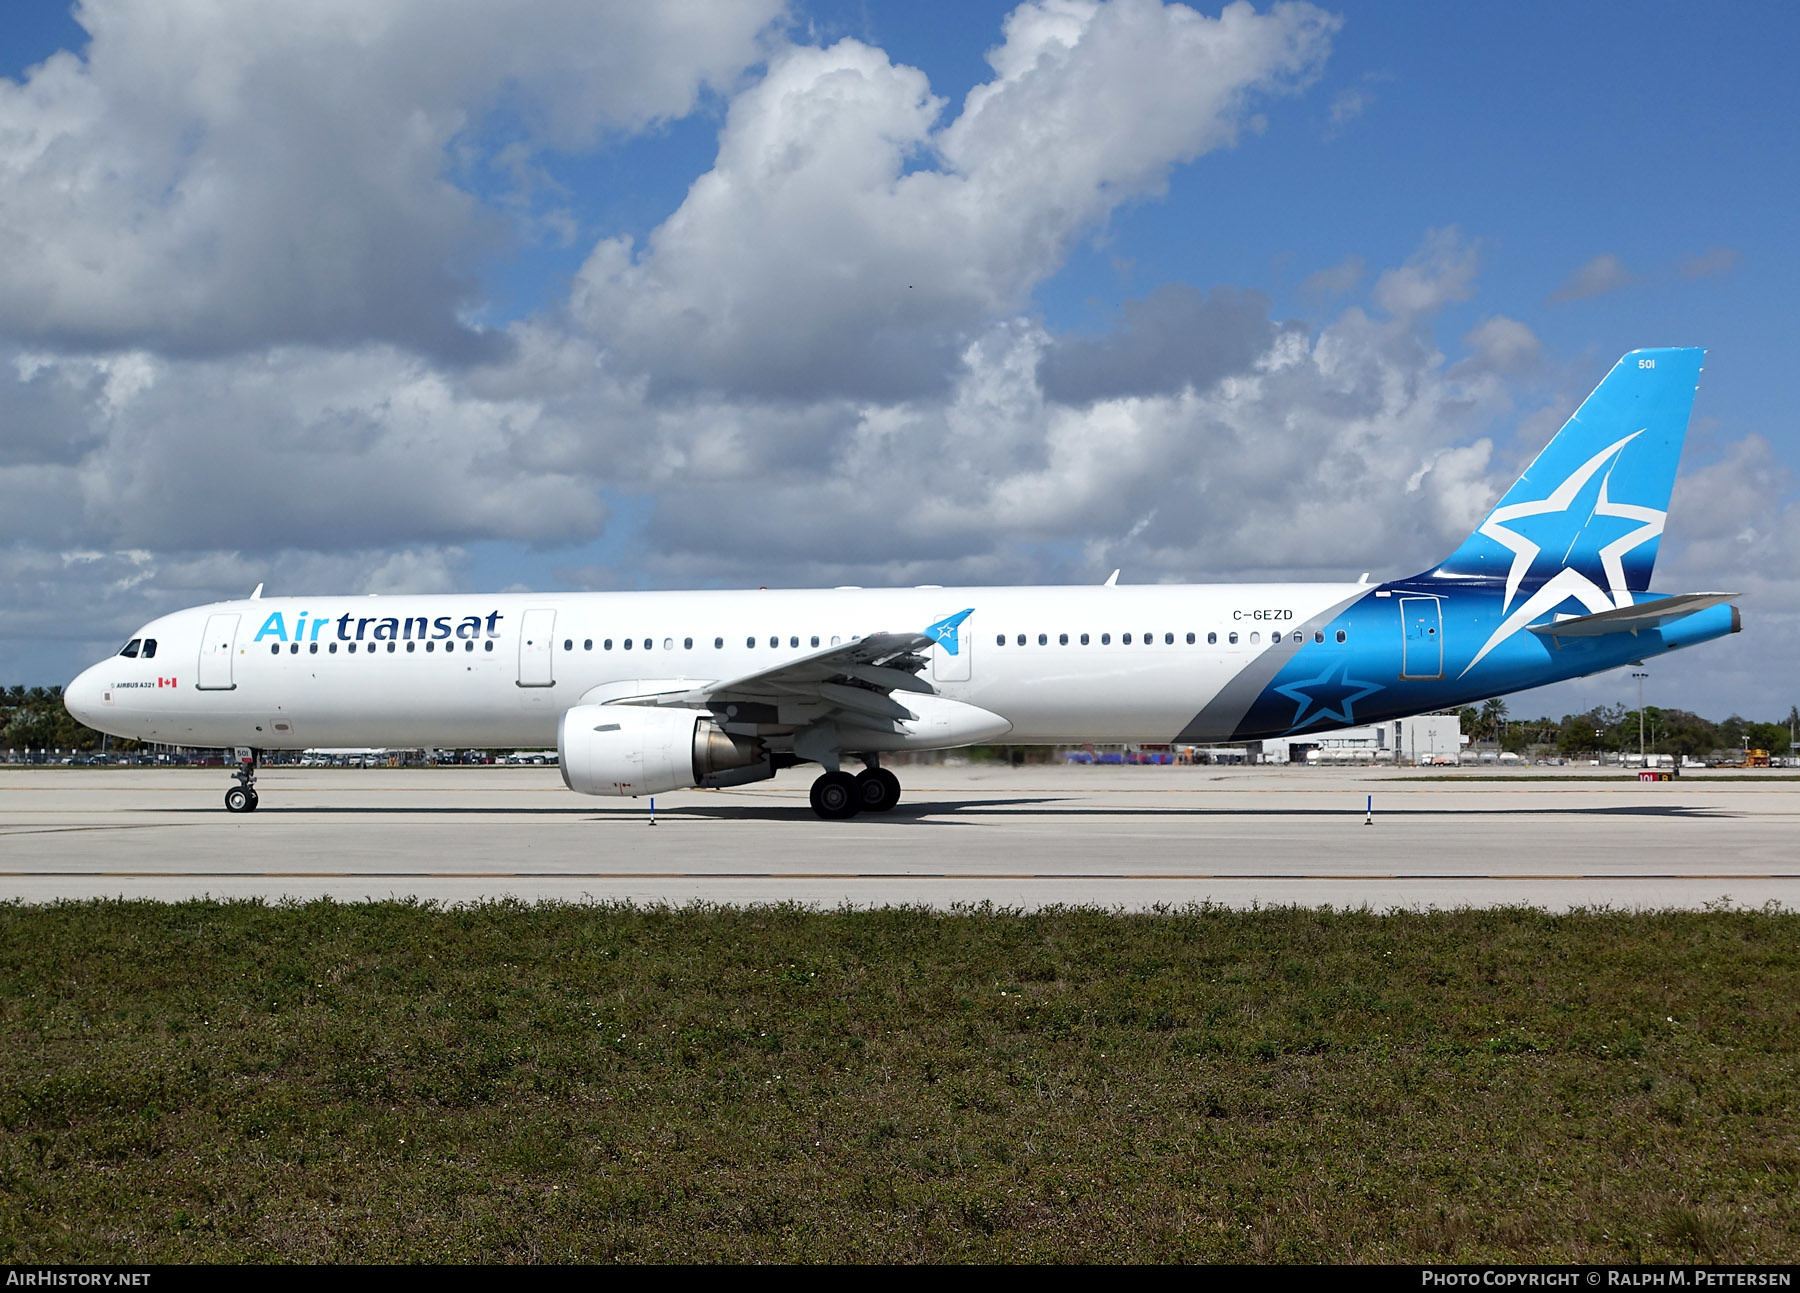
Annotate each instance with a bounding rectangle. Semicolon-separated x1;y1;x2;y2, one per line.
65;349;1739;818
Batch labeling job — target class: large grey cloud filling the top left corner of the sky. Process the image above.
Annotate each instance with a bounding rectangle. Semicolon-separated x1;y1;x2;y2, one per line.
0;0;779;357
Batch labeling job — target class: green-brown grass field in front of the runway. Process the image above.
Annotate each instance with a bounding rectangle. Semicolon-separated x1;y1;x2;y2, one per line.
0;902;1800;1262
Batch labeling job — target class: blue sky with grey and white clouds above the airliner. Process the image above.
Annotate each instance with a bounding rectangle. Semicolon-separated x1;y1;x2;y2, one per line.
0;0;1800;717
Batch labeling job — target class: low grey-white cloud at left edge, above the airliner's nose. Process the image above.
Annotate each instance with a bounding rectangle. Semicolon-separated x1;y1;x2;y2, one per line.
0;348;605;551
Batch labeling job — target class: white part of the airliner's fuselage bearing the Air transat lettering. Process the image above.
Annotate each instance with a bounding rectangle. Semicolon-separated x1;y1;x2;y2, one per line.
67;583;1366;749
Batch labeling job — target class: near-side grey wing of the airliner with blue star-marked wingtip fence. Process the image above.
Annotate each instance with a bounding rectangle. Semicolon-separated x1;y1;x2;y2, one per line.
608;610;970;729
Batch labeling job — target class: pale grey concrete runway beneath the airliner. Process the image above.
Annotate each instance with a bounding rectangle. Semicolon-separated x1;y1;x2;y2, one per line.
0;767;1800;909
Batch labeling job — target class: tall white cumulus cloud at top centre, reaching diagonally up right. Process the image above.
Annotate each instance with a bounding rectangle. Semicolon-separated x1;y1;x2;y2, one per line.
572;0;1337;398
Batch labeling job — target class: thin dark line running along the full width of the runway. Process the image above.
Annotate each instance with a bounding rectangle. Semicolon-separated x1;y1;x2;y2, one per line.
0;872;1800;881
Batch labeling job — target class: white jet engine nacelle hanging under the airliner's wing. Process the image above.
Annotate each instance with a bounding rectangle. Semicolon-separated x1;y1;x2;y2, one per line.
556;704;776;796
